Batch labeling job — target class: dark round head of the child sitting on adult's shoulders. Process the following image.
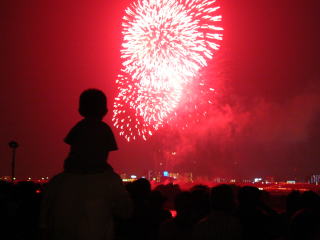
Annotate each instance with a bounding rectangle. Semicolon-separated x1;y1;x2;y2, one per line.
79;89;108;119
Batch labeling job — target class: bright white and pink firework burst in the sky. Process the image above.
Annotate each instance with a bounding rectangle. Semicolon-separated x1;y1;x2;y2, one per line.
113;0;223;141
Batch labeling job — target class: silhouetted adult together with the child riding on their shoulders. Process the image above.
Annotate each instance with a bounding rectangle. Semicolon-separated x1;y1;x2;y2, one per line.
39;89;132;240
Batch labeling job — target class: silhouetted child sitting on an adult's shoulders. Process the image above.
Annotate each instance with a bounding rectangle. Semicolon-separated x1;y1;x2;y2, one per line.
64;89;118;173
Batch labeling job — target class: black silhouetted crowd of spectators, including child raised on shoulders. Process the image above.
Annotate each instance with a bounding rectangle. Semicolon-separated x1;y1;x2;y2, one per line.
0;89;320;240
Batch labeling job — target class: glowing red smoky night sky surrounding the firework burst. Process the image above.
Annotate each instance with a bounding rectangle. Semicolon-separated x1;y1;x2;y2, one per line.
0;0;320;177
